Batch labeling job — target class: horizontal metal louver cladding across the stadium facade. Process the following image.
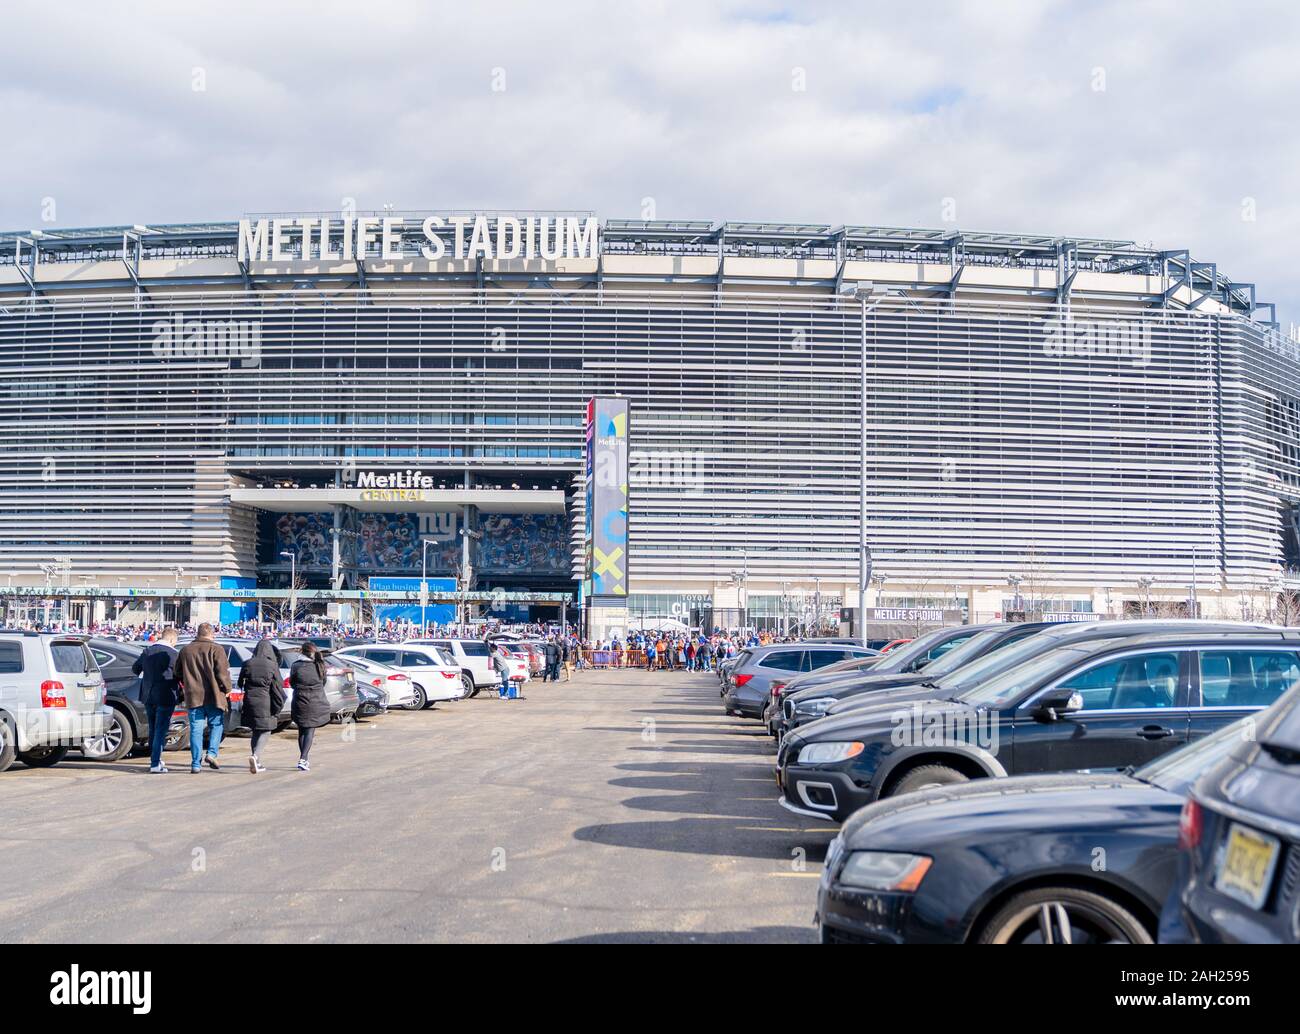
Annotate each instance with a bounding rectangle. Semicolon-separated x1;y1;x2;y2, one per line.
0;274;1300;587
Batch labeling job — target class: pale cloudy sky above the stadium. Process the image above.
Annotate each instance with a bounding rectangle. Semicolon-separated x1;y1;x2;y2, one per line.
0;0;1300;319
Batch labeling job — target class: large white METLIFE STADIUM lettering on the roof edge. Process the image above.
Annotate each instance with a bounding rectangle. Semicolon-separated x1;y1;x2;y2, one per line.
238;215;601;263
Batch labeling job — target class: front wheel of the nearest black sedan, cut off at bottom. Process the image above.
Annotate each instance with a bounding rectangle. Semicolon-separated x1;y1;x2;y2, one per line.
979;887;1152;944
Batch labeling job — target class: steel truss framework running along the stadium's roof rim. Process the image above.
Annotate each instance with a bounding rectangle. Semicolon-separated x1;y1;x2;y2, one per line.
0;211;1277;321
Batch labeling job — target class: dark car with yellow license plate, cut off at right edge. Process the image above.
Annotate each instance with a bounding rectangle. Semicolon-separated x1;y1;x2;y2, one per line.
1160;670;1300;944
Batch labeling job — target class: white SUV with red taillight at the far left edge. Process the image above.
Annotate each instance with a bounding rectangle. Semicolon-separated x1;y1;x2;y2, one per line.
0;632;112;771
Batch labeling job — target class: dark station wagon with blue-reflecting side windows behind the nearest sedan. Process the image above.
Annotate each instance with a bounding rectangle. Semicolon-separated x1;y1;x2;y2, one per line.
777;631;1300;821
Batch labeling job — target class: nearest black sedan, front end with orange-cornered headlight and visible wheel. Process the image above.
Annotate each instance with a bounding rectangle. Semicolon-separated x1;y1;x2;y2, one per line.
818;723;1244;944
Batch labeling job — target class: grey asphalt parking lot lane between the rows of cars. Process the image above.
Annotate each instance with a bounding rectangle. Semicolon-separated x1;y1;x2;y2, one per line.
0;670;835;942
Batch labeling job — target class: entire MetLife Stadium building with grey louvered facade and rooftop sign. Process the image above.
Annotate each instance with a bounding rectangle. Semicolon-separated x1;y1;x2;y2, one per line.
0;212;1300;624
